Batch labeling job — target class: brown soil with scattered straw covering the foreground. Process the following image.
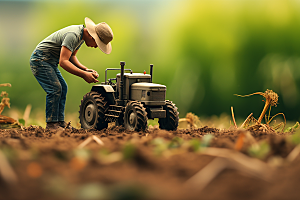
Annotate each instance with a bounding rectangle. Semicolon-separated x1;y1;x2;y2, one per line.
0;126;300;200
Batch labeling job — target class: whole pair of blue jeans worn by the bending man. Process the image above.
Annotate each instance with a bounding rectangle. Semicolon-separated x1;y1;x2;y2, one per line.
30;50;68;122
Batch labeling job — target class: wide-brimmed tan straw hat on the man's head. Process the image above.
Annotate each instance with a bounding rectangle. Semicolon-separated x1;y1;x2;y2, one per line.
84;17;114;54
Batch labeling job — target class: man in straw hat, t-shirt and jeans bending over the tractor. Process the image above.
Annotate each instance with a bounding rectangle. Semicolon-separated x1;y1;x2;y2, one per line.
30;17;113;130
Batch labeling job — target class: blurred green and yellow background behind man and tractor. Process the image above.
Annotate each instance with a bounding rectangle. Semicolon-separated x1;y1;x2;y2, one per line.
0;0;300;126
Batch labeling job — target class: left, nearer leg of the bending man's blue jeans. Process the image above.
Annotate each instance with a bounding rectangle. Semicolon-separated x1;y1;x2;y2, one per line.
30;60;62;122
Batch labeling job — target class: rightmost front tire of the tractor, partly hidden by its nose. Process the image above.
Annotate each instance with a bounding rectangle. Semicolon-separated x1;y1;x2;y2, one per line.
158;101;179;131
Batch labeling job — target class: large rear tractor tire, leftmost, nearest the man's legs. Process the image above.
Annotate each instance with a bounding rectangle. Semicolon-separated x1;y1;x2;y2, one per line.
79;92;108;130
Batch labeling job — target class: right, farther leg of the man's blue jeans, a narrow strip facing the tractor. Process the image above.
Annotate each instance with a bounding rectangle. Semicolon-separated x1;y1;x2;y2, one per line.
55;68;68;121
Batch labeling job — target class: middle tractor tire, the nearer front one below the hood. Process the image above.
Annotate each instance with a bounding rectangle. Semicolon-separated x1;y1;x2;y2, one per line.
124;101;148;131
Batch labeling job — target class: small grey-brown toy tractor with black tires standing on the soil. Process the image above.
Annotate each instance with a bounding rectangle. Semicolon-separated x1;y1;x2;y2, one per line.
79;62;179;131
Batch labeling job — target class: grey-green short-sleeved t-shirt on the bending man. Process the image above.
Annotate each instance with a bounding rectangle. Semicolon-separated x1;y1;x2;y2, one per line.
36;25;84;61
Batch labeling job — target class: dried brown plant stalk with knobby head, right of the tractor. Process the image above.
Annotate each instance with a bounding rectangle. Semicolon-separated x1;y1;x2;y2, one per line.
235;89;278;123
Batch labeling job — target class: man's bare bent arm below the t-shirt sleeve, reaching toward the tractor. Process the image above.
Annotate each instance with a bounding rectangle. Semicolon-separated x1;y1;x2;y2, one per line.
59;46;98;83
